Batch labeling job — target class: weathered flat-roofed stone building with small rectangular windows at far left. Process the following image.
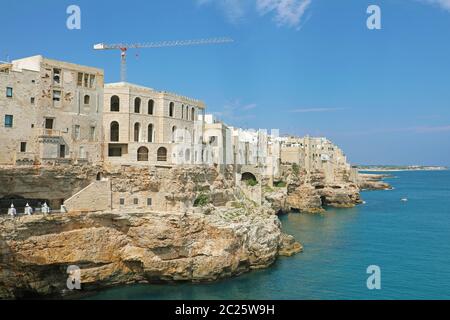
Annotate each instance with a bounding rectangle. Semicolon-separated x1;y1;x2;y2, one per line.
0;56;103;165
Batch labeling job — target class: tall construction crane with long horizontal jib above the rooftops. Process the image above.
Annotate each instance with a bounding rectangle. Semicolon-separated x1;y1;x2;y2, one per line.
94;38;233;82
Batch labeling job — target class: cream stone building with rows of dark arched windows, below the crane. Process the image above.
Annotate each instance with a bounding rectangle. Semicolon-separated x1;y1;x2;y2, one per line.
103;82;205;165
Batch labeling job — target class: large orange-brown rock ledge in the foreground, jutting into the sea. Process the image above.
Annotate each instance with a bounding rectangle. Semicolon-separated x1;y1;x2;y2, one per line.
0;208;301;298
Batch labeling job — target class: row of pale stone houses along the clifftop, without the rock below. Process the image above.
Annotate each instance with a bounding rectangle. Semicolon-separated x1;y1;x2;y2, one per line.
0;56;356;212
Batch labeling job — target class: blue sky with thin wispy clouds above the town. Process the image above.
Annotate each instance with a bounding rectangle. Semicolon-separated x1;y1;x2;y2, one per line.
0;0;450;165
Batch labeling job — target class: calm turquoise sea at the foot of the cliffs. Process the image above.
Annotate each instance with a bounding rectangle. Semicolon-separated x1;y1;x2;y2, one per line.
90;171;450;300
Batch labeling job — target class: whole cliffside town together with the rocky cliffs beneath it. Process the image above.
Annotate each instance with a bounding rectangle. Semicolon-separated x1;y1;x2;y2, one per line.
0;56;390;298
